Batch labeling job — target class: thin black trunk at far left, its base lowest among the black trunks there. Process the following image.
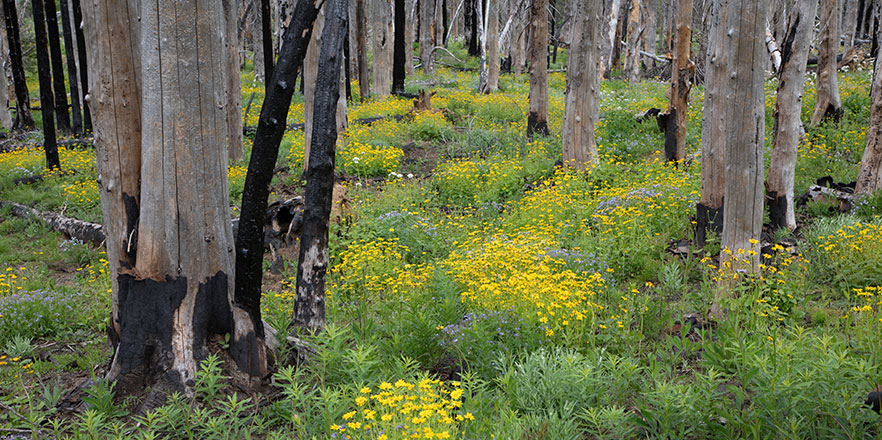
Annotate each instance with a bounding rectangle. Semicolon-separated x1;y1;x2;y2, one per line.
31;0;61;170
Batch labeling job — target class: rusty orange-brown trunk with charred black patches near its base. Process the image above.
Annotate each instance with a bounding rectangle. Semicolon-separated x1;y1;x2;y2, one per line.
665;0;695;161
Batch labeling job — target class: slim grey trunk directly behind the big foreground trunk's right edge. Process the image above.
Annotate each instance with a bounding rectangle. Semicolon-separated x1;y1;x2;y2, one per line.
221;0;245;161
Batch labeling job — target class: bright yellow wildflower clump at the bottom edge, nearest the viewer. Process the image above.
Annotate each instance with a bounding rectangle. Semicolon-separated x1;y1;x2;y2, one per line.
330;378;475;440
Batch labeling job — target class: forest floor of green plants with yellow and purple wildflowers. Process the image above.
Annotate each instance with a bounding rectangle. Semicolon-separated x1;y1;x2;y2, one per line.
0;48;882;440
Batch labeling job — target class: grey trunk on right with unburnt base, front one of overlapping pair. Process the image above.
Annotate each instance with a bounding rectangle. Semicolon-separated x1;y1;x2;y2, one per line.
722;0;768;272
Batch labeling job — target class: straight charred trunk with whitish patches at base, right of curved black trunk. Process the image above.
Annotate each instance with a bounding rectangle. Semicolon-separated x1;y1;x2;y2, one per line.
292;0;349;330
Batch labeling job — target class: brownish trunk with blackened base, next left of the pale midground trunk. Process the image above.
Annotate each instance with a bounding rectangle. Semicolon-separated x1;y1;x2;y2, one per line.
527;0;548;138
